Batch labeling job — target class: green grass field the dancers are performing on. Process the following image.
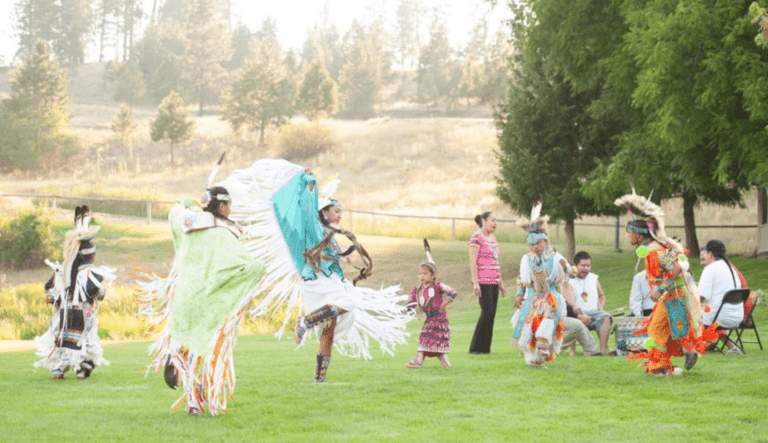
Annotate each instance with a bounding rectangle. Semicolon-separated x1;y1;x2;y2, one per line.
0;224;768;442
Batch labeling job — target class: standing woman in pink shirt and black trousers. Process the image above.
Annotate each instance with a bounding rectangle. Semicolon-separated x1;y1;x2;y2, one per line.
469;212;505;354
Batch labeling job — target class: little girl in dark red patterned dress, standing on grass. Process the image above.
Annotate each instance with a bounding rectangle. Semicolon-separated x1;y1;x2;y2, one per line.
405;261;456;369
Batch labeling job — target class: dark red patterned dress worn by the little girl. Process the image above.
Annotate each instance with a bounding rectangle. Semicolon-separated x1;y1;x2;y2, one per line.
408;281;456;357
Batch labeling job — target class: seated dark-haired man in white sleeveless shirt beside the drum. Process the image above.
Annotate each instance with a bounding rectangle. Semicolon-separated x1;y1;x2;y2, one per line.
569;251;612;354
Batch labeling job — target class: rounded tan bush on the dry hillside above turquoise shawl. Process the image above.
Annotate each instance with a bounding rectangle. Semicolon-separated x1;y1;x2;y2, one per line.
273;123;333;160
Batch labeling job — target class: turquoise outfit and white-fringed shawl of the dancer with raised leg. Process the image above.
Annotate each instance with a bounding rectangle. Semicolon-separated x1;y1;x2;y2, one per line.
220;160;412;382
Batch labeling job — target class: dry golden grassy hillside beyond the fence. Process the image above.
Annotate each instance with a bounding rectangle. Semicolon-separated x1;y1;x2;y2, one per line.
0;64;757;252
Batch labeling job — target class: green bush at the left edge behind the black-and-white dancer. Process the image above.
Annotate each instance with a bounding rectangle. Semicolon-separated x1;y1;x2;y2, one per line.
0;209;61;269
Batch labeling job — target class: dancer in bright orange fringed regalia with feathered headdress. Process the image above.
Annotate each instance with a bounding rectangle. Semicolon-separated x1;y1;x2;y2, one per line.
615;189;720;375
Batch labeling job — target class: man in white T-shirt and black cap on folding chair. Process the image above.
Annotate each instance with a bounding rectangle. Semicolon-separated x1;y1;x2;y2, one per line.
699;240;748;354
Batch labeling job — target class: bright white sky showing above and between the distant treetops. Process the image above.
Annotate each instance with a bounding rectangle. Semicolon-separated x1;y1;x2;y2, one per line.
0;0;511;65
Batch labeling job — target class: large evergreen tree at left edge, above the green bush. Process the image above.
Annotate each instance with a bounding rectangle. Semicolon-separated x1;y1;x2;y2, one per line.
0;40;79;171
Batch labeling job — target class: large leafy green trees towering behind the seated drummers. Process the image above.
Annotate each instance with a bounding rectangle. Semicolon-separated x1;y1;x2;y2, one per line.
496;0;768;262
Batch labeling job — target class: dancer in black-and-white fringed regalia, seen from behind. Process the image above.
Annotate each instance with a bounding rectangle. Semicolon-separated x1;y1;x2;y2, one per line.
34;206;115;380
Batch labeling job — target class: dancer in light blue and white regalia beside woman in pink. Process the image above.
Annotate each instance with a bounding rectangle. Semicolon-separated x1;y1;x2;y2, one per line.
512;197;569;367
